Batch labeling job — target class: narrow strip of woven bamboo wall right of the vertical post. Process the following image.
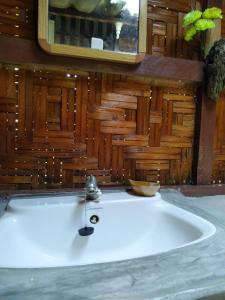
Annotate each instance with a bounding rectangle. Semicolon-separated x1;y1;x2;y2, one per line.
212;94;225;183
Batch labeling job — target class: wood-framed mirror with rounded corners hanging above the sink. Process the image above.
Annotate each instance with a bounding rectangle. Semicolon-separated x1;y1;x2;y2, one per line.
39;0;147;63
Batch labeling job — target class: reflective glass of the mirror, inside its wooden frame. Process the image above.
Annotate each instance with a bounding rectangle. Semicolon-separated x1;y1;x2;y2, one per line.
48;0;139;53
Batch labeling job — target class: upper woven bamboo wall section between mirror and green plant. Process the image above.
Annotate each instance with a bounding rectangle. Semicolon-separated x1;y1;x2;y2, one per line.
147;0;202;59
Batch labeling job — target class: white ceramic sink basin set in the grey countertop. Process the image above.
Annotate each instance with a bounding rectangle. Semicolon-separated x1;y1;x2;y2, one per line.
0;192;215;268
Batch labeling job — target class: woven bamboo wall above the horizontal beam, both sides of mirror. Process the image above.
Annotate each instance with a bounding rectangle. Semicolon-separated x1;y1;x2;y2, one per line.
0;0;201;59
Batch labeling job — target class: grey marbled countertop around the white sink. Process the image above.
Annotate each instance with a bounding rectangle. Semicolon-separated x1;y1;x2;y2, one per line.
0;189;225;300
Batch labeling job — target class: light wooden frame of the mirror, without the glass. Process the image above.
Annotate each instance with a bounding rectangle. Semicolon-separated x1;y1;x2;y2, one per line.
38;0;147;63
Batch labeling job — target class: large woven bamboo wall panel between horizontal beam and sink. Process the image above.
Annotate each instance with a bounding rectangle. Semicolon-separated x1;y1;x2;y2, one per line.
0;68;195;188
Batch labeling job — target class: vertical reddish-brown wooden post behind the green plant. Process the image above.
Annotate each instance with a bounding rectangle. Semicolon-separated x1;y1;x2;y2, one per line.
193;0;221;184
